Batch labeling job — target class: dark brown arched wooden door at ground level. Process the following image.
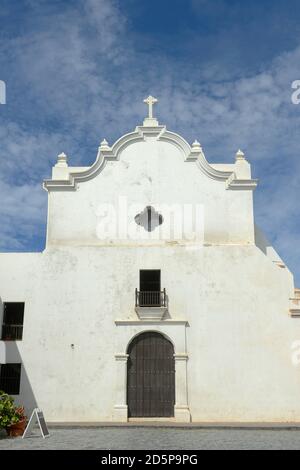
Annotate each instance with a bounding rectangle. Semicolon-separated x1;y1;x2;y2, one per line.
127;332;175;418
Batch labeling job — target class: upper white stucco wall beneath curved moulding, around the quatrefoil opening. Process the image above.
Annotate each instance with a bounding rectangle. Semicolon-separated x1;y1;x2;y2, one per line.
47;138;254;245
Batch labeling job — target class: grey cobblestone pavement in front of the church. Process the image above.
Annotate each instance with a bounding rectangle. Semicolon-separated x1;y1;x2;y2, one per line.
0;427;300;450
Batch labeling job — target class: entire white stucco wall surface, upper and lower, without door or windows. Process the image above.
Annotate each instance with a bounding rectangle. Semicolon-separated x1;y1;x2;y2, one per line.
0;120;300;422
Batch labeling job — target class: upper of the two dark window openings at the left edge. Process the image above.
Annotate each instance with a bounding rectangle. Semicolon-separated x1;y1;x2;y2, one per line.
1;302;25;341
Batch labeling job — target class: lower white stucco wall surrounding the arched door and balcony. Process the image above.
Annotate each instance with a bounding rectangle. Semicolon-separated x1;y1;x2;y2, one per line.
0;246;300;421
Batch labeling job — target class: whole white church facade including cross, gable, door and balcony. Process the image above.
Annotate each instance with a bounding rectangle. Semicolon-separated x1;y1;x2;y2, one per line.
0;97;300;423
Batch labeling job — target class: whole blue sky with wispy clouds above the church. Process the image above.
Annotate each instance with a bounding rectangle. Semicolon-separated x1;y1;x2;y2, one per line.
0;0;300;286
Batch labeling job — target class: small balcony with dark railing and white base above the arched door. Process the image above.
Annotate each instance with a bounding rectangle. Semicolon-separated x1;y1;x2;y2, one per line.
135;289;167;320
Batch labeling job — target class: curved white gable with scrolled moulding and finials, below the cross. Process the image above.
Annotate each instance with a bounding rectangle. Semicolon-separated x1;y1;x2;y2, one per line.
44;98;257;245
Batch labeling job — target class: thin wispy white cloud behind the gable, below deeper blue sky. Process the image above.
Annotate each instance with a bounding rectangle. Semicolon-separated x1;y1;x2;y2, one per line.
0;0;300;281
